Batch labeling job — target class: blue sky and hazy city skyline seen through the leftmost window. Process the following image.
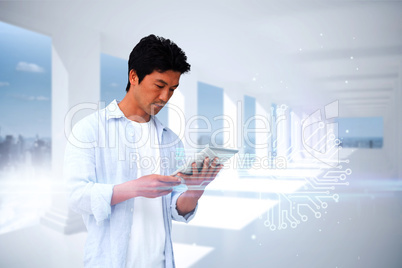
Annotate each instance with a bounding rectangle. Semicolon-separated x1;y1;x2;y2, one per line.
0;22;52;171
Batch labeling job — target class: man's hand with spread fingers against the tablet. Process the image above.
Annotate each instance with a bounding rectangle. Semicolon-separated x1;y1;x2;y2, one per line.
177;157;223;191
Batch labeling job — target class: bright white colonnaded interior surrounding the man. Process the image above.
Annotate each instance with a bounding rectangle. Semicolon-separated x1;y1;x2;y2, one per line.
0;0;402;268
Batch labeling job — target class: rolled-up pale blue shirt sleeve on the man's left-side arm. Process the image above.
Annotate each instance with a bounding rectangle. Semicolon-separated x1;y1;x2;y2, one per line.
64;118;114;225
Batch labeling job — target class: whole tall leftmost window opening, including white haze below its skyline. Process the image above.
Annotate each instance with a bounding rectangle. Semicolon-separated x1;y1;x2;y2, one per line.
0;22;52;234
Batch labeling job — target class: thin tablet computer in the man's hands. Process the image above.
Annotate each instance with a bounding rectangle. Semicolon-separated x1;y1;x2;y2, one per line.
172;146;239;176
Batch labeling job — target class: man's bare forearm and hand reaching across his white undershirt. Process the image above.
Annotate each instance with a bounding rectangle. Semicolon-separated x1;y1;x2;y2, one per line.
110;174;181;206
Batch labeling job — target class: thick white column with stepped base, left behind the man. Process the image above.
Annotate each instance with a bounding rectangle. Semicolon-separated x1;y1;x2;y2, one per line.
41;28;100;234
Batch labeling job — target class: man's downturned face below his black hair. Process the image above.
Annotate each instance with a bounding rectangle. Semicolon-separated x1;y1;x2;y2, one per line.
128;70;181;119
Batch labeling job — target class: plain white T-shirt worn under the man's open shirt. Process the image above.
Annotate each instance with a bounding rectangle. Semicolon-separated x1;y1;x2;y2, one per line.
126;120;165;268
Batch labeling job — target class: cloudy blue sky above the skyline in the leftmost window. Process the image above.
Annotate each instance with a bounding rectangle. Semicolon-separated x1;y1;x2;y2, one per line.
0;22;52;137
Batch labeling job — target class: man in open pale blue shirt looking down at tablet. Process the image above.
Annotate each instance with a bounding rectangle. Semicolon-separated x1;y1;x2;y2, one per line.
65;35;221;267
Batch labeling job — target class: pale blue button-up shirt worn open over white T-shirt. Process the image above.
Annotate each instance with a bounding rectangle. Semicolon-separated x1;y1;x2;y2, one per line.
64;100;196;268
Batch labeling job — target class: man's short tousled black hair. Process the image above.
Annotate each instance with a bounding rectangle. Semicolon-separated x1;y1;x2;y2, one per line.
126;34;190;91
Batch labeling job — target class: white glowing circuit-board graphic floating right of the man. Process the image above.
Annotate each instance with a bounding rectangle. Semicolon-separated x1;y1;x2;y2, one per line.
263;101;352;231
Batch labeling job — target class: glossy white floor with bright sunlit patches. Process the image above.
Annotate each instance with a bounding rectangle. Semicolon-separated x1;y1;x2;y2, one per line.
0;150;402;268
